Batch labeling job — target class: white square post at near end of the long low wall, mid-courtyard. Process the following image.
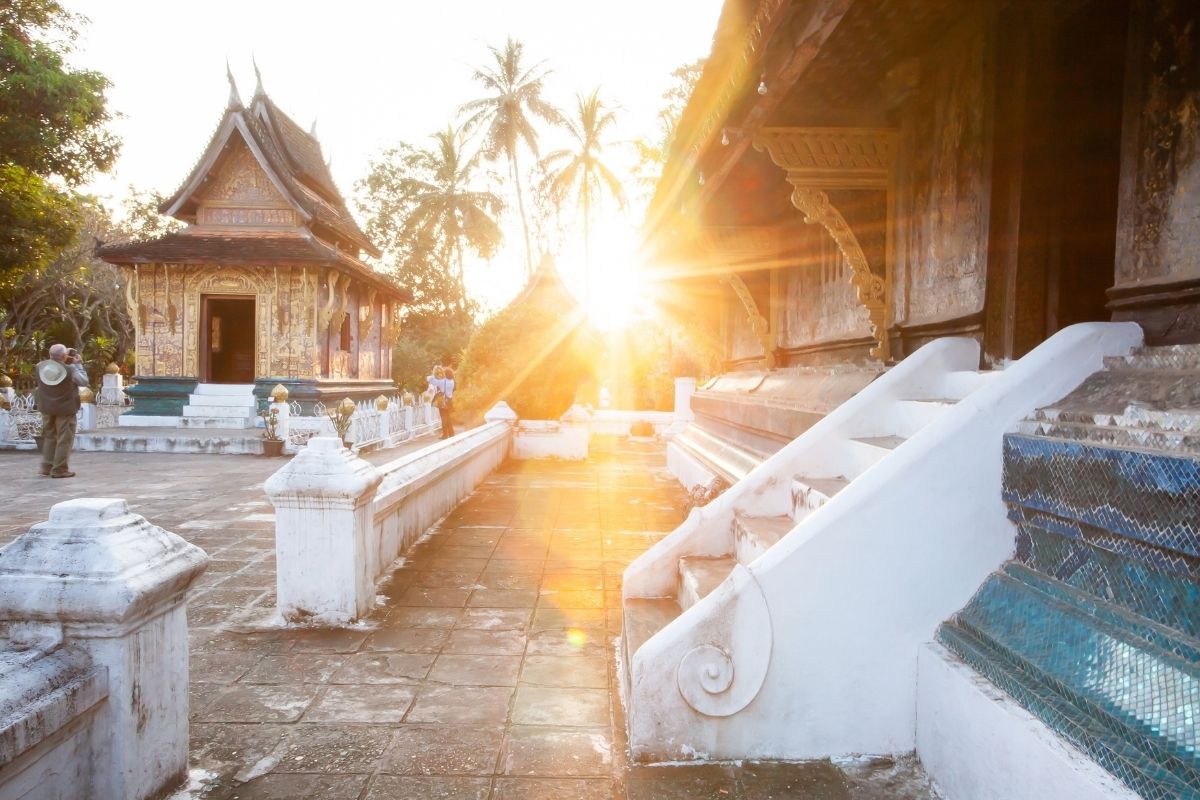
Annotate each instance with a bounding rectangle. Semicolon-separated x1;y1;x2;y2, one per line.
264;437;380;625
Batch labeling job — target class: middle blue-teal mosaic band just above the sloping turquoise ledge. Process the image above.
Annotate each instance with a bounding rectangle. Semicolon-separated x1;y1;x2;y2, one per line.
1016;516;1200;647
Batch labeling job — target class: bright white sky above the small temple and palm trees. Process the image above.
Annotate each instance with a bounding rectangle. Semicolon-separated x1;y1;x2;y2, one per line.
65;0;721;316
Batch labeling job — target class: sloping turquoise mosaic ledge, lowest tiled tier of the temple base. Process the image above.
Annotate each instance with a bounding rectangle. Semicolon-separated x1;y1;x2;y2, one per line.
938;564;1200;798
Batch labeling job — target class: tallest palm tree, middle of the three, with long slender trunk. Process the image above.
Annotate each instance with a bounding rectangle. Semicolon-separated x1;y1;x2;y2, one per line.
460;36;562;280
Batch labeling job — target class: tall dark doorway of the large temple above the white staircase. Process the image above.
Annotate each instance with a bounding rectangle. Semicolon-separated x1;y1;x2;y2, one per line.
986;0;1129;359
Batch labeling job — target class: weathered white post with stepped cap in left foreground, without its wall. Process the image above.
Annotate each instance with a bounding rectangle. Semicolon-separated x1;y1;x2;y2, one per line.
0;498;209;800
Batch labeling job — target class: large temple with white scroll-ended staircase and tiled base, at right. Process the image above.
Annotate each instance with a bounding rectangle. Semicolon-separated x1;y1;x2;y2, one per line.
622;0;1200;800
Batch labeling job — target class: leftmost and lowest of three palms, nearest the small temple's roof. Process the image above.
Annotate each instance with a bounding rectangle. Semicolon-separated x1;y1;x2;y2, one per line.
398;125;504;311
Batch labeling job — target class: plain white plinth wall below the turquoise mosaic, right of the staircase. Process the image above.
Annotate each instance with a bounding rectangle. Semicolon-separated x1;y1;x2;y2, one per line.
917;642;1138;800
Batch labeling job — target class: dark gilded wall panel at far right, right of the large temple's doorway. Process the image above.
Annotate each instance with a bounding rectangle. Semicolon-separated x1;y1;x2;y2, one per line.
1109;0;1200;342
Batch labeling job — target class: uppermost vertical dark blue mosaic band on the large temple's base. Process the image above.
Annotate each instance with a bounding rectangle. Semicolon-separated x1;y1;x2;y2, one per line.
1003;433;1200;558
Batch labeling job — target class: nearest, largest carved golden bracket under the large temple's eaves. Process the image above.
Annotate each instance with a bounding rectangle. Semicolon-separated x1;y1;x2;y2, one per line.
754;128;896;360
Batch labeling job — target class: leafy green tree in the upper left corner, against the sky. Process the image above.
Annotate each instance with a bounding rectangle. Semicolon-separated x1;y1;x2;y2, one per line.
0;0;119;281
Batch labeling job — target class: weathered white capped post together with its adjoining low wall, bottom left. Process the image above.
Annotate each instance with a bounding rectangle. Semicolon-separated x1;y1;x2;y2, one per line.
0;498;208;800
